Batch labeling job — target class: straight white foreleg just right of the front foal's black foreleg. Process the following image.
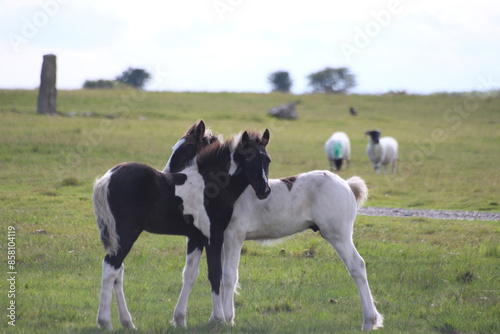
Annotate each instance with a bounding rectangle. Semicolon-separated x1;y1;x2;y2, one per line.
222;230;245;325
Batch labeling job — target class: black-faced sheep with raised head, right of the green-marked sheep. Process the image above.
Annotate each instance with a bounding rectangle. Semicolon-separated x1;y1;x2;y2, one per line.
365;130;398;173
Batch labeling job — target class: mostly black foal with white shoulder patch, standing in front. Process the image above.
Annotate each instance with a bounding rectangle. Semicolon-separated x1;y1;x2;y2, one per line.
93;129;271;329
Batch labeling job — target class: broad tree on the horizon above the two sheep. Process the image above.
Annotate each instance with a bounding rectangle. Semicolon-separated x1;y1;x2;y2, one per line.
307;67;356;94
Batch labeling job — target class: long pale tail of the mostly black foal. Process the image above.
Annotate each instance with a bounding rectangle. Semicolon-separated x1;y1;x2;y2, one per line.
92;171;119;255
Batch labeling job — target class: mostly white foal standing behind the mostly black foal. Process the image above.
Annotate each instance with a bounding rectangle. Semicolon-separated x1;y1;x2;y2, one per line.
170;126;384;330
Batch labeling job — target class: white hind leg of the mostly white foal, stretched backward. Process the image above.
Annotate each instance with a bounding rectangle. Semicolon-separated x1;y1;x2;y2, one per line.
323;235;384;330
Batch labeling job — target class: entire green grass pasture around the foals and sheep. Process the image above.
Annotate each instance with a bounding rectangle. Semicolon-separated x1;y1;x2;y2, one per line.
0;90;500;333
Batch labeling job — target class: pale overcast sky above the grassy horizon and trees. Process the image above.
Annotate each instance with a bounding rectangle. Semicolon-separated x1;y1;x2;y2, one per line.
0;0;500;94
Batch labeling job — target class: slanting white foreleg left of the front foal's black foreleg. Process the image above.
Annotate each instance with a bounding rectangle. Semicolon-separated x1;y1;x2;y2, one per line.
170;238;203;327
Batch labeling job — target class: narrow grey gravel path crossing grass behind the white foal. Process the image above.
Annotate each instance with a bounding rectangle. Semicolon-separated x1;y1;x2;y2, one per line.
358;207;500;221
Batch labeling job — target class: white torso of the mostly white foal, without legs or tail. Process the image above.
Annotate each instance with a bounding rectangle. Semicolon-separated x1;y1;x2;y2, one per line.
228;170;357;240
